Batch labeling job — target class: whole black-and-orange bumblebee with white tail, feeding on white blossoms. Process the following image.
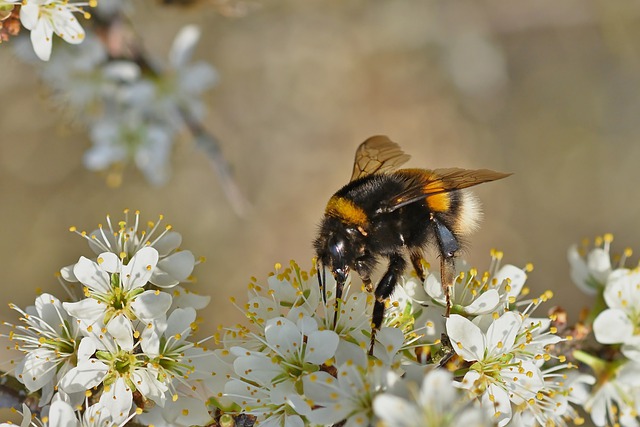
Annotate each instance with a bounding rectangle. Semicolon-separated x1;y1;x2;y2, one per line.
314;135;511;353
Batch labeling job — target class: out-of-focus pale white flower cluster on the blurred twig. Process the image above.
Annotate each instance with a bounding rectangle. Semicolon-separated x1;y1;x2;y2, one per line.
13;19;217;186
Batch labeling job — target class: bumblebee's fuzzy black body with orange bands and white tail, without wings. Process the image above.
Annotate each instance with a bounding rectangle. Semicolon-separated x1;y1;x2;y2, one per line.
315;169;472;268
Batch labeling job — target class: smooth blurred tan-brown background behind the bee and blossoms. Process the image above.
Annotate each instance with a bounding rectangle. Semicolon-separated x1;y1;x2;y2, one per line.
0;0;640;354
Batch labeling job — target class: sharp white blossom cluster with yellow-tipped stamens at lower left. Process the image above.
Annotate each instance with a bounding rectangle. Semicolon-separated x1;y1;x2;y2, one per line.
5;211;215;425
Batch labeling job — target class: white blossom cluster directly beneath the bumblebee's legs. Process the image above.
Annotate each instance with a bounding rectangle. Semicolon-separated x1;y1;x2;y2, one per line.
206;251;578;426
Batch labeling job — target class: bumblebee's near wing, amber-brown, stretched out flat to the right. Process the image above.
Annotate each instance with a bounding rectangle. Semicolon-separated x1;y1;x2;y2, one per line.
378;168;511;212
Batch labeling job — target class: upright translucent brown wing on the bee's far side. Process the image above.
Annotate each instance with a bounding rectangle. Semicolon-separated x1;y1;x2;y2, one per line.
351;135;411;181
